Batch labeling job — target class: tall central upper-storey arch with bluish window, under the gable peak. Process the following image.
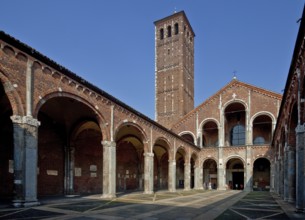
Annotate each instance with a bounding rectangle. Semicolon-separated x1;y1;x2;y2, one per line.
225;102;246;146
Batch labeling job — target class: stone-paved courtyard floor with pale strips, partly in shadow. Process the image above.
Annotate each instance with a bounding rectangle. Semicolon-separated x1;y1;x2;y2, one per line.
0;190;305;220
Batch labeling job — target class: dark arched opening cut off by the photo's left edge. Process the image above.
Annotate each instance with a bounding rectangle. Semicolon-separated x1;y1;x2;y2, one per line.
0;83;14;198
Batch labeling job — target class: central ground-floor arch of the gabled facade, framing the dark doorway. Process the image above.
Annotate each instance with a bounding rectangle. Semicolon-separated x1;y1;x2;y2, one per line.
226;158;244;190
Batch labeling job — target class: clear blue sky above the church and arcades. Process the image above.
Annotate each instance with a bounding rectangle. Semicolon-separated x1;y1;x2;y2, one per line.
0;0;304;119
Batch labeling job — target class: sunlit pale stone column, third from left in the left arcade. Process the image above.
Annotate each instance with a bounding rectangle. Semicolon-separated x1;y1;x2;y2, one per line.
144;153;154;194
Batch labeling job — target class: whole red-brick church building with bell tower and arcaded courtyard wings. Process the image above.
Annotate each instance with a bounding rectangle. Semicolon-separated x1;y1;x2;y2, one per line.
0;8;305;209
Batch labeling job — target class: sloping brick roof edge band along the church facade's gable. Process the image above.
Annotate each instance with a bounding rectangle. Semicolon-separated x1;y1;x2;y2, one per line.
172;79;282;128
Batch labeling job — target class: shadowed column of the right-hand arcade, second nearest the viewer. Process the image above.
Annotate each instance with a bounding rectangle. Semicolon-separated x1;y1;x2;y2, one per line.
284;146;296;203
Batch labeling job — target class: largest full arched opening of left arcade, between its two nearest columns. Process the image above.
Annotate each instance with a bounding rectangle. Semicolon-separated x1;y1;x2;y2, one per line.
37;96;103;196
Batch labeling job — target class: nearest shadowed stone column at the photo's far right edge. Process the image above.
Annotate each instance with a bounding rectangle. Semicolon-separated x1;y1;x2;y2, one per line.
295;124;305;211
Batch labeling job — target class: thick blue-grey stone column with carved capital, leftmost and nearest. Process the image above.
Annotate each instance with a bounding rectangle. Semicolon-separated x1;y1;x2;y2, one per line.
11;115;40;207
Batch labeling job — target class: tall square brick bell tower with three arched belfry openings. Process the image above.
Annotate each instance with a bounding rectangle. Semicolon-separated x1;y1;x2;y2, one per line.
154;11;195;128
